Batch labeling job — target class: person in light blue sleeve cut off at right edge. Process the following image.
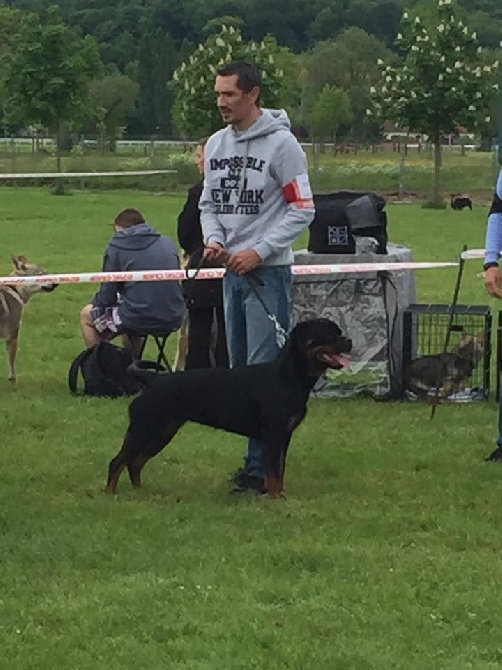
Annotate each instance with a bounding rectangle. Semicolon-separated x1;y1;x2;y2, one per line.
484;169;502;461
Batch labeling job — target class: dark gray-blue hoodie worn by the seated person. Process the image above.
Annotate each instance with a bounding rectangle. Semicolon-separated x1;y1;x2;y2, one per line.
92;223;185;332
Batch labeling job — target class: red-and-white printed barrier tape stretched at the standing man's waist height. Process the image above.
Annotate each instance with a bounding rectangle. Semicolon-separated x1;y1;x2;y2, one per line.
0;261;457;286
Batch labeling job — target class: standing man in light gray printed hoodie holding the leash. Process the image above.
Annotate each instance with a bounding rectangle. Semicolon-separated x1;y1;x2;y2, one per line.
199;61;314;492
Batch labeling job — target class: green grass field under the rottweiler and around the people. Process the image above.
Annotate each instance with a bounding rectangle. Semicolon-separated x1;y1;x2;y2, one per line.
0;189;502;670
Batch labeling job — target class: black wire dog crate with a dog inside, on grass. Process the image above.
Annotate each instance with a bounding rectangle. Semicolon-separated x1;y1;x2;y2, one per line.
402;304;492;402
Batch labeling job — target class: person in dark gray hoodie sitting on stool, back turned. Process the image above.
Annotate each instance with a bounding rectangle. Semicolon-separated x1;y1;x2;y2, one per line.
80;209;185;350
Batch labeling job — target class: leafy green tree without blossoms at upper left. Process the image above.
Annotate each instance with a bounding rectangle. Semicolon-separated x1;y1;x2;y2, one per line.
5;7;100;170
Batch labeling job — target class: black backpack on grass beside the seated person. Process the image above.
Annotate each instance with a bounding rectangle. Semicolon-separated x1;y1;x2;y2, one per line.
68;342;141;398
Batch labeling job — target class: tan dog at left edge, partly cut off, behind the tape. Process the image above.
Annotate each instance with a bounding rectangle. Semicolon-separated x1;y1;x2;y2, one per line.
0;256;57;382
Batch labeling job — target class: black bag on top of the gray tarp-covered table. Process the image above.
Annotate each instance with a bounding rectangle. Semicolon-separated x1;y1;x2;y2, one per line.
308;191;388;254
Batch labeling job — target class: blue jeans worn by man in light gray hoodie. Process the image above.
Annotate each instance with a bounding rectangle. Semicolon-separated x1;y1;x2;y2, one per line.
223;266;293;477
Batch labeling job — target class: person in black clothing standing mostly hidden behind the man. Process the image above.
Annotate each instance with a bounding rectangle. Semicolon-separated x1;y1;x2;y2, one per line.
178;140;228;370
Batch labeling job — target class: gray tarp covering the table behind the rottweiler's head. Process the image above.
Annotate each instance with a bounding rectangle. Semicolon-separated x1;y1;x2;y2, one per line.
292;243;416;397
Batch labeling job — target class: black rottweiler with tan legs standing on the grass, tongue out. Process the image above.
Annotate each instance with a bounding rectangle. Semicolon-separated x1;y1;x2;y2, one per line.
106;319;352;497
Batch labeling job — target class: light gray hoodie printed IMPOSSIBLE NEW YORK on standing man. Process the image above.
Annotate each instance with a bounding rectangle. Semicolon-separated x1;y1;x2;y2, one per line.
199;109;314;265
